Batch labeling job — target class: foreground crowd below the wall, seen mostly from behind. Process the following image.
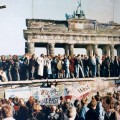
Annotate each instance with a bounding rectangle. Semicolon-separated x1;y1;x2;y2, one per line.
0;92;120;120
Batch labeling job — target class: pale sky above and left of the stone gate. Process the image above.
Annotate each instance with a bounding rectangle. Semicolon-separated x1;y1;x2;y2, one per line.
0;0;120;55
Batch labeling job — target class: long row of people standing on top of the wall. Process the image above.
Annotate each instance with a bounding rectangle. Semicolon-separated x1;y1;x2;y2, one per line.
0;54;120;81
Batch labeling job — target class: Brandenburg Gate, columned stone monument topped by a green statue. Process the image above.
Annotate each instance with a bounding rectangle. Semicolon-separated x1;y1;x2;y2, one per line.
24;0;120;56
